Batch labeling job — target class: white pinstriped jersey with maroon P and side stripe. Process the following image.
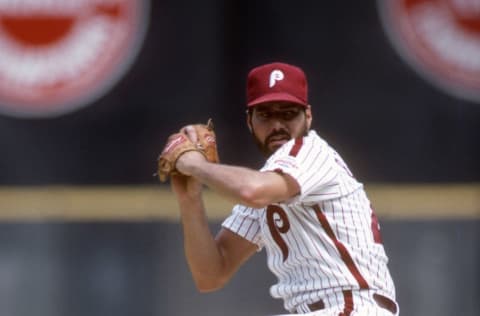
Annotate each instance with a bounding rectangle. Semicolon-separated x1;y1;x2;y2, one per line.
222;131;395;310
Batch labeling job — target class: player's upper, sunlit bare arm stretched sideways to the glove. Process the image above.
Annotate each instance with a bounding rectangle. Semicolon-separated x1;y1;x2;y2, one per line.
177;151;300;208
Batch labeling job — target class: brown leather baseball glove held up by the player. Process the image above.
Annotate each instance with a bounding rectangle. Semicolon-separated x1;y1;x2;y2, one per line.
157;119;219;182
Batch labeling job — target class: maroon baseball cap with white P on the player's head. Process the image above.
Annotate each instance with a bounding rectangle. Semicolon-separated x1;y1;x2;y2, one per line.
247;62;308;107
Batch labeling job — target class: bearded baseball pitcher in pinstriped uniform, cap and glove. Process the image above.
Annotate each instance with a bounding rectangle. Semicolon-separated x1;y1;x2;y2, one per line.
158;63;399;316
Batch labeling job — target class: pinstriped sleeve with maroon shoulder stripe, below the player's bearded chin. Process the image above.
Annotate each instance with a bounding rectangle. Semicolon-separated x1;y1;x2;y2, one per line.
260;131;339;204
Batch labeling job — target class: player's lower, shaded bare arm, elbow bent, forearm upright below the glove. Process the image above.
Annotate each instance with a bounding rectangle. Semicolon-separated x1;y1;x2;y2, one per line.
171;176;257;292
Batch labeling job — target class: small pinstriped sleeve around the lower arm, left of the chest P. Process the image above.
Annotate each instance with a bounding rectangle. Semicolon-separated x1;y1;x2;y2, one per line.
222;205;264;251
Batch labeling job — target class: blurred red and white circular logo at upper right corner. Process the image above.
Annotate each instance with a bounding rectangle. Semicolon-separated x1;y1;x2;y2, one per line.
377;0;480;103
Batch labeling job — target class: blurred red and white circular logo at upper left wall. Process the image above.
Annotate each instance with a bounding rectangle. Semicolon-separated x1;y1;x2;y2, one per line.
0;0;148;117
